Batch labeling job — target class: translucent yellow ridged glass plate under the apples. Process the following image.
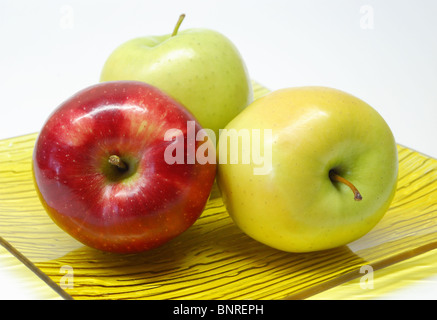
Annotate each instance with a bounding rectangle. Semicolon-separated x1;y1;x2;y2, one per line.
0;83;437;300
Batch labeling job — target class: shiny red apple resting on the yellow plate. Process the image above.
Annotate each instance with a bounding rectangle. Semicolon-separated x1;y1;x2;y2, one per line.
32;81;216;253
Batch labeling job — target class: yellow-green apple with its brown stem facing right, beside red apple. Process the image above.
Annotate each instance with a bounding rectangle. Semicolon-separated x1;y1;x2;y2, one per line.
217;87;398;252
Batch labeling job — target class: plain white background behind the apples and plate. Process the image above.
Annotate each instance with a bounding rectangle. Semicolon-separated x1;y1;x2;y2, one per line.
0;0;437;296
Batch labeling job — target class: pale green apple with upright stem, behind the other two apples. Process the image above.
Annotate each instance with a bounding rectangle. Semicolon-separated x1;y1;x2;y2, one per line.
100;15;253;137
